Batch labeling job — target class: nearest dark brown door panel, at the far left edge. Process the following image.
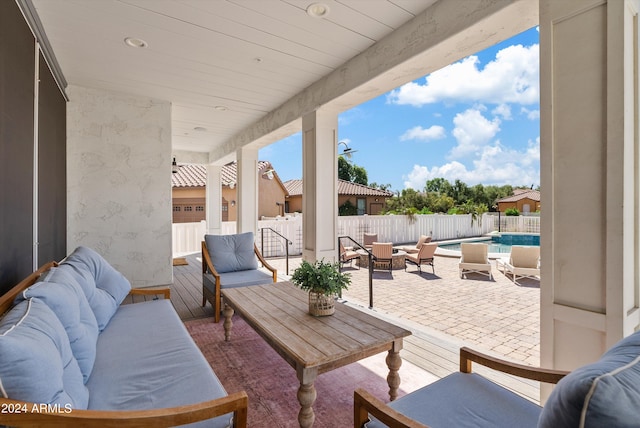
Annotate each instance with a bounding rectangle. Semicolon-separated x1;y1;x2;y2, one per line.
0;1;35;294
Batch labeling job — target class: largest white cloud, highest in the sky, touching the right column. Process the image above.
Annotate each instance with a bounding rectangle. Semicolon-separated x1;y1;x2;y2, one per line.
387;44;540;107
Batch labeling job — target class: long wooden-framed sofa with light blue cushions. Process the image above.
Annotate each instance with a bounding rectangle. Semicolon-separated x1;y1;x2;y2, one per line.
0;247;247;427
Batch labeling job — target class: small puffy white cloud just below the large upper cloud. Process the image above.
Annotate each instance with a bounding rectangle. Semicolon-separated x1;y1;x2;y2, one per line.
450;106;500;159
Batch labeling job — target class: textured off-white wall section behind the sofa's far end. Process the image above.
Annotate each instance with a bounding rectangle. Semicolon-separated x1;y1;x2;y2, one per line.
67;86;173;287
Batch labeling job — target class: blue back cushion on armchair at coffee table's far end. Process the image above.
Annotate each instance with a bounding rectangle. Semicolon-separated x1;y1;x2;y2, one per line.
204;232;258;273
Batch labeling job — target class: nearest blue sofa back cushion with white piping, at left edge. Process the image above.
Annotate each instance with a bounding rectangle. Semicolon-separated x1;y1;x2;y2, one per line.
0;298;89;410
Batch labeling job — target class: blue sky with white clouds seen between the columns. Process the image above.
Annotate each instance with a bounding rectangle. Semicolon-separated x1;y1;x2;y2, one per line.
258;28;540;191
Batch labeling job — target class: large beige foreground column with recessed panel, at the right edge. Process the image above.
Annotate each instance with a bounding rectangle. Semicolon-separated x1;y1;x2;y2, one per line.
540;0;640;402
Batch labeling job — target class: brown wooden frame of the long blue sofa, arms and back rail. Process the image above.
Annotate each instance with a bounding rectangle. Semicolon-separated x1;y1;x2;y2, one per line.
0;262;249;428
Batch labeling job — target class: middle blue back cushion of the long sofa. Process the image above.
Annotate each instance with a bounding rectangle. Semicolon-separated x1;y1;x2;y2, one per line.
16;278;98;382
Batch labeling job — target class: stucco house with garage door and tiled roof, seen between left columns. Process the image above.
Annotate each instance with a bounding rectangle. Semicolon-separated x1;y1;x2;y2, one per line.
171;161;287;223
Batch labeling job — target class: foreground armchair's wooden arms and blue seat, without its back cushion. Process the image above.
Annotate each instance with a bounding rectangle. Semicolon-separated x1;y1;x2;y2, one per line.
353;347;567;428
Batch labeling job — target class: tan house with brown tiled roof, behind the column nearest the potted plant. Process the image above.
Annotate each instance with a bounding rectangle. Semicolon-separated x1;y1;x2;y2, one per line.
284;179;393;215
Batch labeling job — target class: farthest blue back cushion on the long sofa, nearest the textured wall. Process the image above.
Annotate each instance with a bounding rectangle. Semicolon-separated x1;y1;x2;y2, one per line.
56;246;131;331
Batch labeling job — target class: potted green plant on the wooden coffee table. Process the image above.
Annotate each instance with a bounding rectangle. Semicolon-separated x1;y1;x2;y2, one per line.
291;259;351;316
